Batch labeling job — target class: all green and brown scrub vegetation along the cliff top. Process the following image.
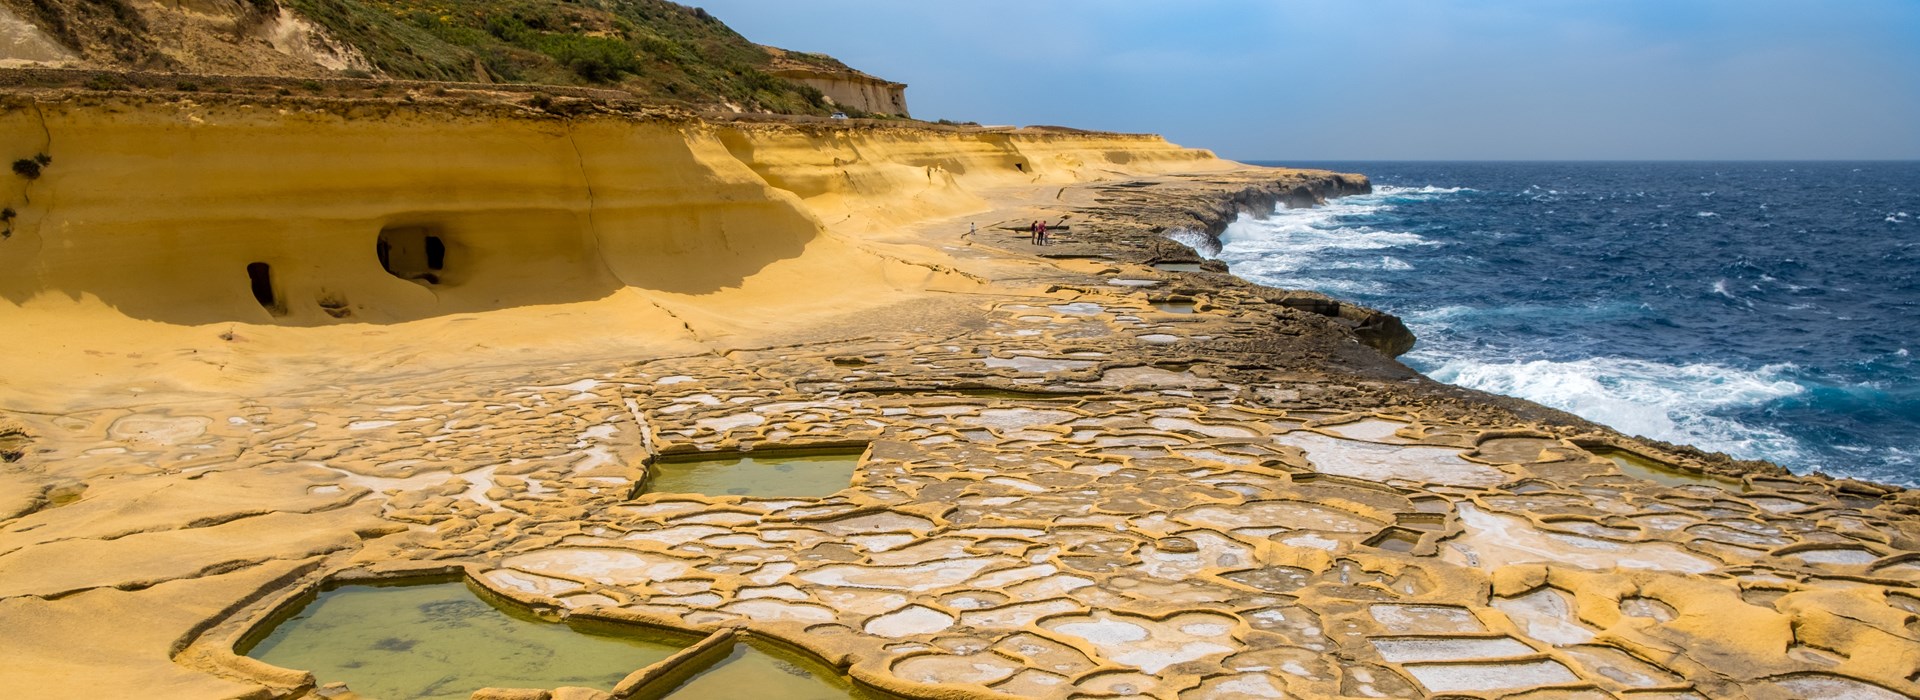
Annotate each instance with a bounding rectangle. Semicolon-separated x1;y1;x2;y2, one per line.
0;0;852;115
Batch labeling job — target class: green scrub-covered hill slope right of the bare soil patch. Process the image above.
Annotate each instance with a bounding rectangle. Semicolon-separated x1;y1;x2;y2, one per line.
280;0;839;115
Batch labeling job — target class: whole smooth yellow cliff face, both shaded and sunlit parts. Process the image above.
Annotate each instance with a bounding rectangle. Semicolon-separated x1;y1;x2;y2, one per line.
0;94;1231;402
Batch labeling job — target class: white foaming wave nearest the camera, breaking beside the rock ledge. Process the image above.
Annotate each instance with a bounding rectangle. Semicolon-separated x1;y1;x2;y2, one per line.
1409;353;1807;462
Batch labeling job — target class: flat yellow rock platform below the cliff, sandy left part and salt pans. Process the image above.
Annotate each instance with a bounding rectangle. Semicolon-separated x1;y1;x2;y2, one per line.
0;93;1920;698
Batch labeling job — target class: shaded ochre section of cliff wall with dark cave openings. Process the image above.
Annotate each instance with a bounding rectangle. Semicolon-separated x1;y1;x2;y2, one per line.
0;113;829;326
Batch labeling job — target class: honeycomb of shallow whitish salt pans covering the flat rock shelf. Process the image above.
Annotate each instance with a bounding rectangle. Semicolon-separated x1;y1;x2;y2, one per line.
0;295;1920;698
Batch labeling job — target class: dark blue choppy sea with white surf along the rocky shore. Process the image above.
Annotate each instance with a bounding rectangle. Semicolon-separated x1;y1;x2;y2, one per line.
1219;163;1920;485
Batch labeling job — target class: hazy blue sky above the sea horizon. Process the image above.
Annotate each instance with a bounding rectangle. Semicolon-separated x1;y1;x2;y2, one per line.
698;0;1920;161
